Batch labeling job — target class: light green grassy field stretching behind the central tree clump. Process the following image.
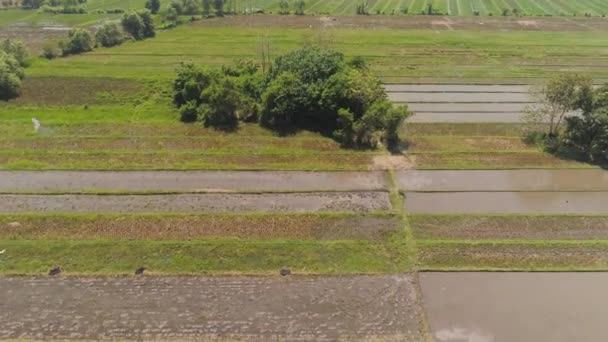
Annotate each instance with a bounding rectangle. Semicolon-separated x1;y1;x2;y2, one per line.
27;24;608;84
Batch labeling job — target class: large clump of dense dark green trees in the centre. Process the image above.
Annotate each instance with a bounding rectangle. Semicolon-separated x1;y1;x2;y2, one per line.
173;47;410;148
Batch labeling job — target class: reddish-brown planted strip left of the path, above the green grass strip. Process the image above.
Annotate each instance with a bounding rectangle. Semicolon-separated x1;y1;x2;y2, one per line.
0;213;400;241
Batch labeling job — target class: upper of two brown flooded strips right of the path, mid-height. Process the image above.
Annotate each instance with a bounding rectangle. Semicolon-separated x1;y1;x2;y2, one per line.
397;169;608;192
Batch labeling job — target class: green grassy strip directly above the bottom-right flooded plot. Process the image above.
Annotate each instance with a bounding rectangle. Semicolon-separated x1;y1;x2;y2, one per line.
417;240;608;271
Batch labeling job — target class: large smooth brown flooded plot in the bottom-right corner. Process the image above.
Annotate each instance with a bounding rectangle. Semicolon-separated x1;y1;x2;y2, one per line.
420;273;608;342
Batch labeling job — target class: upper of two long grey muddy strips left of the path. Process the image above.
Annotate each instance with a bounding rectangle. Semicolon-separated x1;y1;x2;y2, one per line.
0;171;388;193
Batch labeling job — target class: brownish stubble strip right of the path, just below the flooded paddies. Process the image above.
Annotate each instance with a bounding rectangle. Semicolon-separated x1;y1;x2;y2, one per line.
410;215;608;240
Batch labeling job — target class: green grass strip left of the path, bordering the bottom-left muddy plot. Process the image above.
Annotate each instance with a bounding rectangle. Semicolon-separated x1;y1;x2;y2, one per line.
0;239;411;275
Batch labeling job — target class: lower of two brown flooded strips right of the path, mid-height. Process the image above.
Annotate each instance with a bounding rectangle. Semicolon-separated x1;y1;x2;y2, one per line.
405;192;608;214
